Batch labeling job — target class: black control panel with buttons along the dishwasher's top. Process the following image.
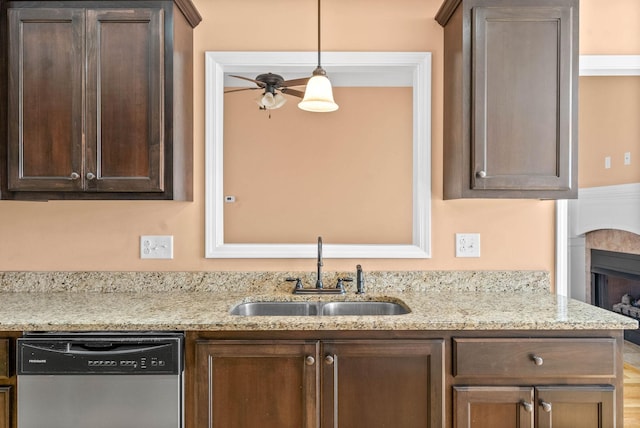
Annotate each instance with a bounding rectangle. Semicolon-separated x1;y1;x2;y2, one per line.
18;336;183;375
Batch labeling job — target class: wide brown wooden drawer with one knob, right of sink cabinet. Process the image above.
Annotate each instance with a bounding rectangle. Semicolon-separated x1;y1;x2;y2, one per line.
453;338;616;378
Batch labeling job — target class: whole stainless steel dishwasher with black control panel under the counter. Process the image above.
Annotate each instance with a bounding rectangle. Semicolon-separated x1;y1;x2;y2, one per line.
17;332;184;428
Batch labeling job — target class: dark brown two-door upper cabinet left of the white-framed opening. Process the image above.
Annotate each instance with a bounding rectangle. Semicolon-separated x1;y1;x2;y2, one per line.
0;0;200;200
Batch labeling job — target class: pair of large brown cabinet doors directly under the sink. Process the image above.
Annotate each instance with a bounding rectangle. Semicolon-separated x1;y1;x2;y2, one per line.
195;340;444;428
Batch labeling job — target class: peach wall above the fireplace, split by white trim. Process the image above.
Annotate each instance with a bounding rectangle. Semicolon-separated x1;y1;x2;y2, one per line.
578;0;640;188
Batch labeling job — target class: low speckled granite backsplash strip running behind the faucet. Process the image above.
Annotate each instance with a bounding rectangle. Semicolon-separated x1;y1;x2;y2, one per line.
0;271;551;293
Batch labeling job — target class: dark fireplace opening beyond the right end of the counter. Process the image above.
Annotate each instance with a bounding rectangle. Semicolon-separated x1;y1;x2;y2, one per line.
591;250;640;345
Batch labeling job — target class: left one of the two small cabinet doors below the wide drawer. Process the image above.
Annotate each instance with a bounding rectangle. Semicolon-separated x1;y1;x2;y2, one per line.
453;386;536;428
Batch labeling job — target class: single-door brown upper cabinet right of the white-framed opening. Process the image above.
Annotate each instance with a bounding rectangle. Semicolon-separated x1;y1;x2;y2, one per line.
436;0;578;199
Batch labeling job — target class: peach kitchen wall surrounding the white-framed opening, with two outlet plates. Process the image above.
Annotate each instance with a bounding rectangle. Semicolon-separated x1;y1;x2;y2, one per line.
0;0;640;271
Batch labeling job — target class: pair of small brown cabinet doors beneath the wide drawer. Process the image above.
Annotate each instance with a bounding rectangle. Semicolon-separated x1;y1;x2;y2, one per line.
453;385;615;428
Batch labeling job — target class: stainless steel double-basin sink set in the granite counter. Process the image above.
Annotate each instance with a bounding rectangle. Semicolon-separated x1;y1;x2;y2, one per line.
230;301;411;316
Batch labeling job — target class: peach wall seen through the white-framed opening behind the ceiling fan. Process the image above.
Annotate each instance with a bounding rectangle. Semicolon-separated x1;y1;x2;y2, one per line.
223;87;413;245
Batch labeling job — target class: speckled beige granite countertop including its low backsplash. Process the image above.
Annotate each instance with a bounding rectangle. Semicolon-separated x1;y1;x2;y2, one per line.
0;272;638;331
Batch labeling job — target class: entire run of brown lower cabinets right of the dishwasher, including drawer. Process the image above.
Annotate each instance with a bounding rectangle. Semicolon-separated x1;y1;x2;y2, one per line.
188;330;624;428
